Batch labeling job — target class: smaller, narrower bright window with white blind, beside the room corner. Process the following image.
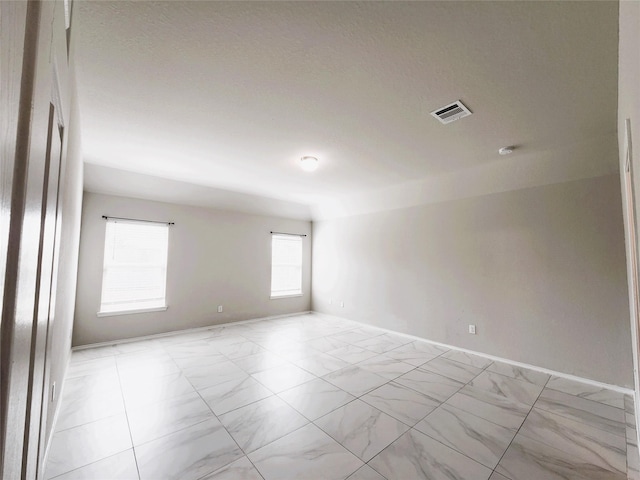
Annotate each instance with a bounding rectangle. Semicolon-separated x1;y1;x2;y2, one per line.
271;233;302;297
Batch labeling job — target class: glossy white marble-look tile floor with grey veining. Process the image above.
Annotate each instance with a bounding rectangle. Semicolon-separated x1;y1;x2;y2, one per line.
46;314;640;480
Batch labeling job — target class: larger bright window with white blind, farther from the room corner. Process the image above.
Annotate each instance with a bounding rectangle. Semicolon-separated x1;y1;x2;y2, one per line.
100;218;169;313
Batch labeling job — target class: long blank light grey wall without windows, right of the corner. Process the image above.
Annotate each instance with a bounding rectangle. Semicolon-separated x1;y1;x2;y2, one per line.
312;175;632;386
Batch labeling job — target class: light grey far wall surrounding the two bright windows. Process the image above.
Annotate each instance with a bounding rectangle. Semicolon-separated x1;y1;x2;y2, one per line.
73;192;311;345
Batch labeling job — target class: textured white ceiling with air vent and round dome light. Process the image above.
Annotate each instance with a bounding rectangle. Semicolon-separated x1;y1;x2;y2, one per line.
74;0;618;218
